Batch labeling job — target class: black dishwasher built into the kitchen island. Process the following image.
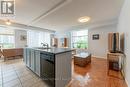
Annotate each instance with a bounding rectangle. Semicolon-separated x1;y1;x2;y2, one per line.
40;52;55;85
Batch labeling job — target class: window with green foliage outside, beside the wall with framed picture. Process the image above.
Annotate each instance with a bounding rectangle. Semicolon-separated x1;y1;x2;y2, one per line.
71;30;88;49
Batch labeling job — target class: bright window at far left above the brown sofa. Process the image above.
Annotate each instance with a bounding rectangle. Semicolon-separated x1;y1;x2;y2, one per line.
0;28;15;48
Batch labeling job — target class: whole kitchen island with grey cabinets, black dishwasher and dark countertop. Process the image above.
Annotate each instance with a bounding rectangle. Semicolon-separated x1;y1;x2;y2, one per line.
24;47;72;87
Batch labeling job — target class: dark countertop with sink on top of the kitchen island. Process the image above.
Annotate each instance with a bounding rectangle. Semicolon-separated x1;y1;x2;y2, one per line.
26;47;73;54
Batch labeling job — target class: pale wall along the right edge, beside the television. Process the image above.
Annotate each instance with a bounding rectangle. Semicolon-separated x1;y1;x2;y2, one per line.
118;0;130;87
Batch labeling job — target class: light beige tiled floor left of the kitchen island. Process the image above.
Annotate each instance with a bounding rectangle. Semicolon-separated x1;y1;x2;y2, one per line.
0;59;48;87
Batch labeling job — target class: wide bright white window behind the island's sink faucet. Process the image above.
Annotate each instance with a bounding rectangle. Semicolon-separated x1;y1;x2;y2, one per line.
27;31;50;47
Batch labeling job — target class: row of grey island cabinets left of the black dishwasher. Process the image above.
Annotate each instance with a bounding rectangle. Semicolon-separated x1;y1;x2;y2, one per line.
24;48;40;76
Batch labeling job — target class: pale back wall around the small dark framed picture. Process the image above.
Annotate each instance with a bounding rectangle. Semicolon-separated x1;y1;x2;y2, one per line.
88;24;117;58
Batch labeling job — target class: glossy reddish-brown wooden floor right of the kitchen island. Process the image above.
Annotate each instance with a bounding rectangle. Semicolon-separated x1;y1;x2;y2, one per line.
69;58;127;87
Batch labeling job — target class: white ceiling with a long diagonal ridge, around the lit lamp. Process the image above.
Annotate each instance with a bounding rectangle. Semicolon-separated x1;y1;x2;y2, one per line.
0;0;123;30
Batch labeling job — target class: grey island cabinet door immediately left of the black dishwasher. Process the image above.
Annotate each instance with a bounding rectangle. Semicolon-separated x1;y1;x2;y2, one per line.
35;51;40;76
